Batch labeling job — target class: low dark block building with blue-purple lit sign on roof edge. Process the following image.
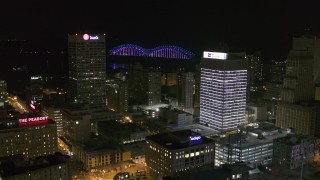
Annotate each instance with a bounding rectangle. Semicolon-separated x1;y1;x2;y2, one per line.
145;130;214;176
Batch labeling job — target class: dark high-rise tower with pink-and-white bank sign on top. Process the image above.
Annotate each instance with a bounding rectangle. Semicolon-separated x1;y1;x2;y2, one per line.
68;34;106;105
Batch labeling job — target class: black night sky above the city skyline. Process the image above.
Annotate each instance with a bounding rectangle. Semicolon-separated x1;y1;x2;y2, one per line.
0;0;320;57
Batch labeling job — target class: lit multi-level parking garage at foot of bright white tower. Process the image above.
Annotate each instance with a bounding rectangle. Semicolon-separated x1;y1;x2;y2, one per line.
215;123;289;168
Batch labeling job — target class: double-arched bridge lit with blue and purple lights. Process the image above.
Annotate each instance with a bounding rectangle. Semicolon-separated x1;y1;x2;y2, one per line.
109;44;194;59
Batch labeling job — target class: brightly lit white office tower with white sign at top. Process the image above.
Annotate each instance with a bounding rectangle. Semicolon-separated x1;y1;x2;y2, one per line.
200;51;247;132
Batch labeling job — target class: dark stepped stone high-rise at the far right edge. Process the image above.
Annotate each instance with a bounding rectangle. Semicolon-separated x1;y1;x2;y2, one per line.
276;50;319;136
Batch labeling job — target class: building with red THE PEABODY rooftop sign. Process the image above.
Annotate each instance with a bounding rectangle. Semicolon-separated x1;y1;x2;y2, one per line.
0;116;58;159
